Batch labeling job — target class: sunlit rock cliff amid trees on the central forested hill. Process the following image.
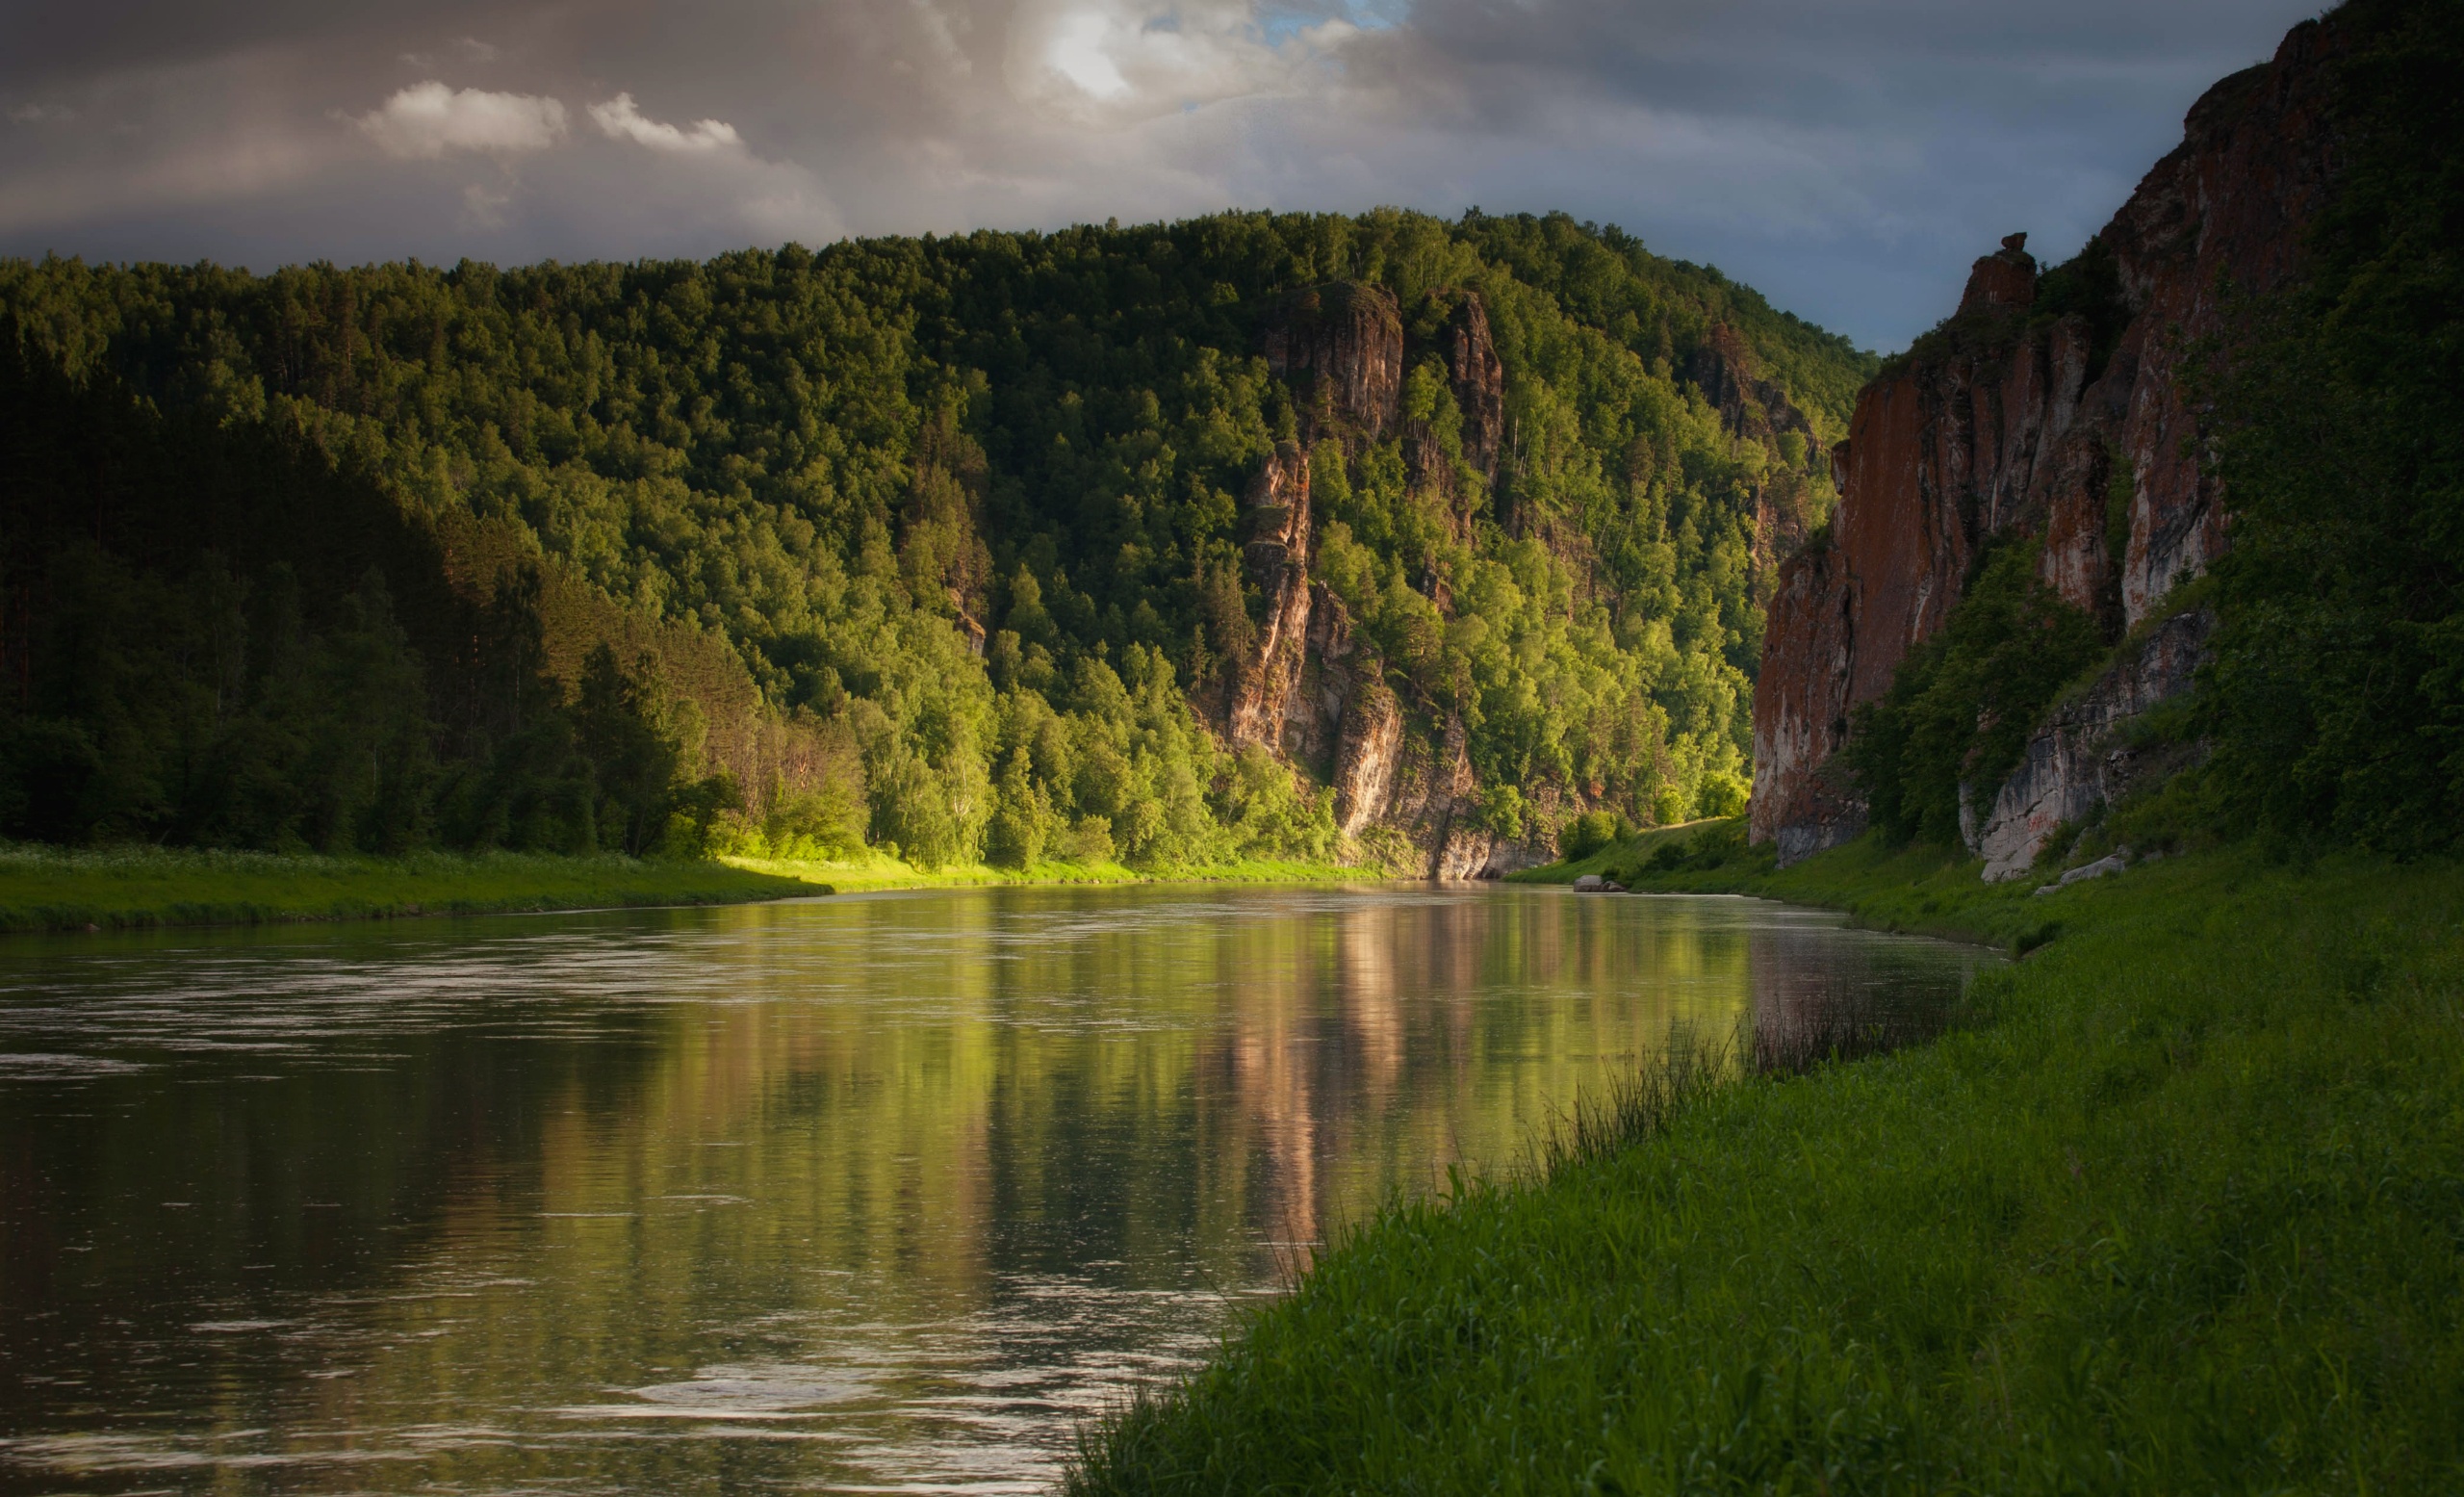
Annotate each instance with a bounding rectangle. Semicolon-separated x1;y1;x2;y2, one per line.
1224;284;1553;878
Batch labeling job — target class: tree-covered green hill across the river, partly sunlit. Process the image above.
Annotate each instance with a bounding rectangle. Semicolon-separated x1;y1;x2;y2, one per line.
0;212;1873;865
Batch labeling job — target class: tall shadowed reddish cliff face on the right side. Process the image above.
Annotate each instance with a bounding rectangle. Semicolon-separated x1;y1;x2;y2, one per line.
1750;22;2336;861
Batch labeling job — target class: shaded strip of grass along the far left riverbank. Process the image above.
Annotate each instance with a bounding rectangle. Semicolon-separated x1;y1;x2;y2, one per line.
0;846;831;930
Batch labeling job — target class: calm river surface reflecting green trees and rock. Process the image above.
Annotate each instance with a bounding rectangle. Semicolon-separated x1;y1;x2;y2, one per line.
0;886;1986;1492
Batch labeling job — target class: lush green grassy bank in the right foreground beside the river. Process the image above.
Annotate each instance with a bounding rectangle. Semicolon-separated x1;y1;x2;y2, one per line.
1072;846;2464;1494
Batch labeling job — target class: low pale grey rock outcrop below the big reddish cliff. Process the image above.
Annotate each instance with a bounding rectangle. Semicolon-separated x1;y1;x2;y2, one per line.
1962;609;2215;881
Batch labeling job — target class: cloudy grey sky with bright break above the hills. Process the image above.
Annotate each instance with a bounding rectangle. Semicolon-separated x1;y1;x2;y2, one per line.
0;0;2319;350
